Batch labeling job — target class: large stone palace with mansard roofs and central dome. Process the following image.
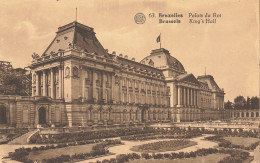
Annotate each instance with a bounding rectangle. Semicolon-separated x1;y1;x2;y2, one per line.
0;22;225;127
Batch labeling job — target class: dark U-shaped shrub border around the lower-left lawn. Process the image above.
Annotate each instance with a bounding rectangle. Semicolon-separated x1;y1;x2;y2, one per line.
9;140;121;163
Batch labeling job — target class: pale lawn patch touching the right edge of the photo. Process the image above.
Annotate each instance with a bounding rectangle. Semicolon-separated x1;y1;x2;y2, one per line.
224;137;259;147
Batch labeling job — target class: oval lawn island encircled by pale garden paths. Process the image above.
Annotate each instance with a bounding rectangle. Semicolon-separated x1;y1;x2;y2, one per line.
131;140;197;153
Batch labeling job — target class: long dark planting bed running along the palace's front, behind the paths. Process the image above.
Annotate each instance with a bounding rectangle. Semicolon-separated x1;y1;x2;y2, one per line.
30;127;202;144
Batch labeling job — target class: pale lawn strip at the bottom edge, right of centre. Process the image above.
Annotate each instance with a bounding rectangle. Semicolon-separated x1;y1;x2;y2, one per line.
129;153;229;163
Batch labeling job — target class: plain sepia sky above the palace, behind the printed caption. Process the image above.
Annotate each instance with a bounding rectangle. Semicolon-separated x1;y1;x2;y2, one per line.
0;0;259;101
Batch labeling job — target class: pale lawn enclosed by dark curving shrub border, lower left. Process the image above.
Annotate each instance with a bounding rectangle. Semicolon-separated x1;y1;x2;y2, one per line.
27;144;96;161
